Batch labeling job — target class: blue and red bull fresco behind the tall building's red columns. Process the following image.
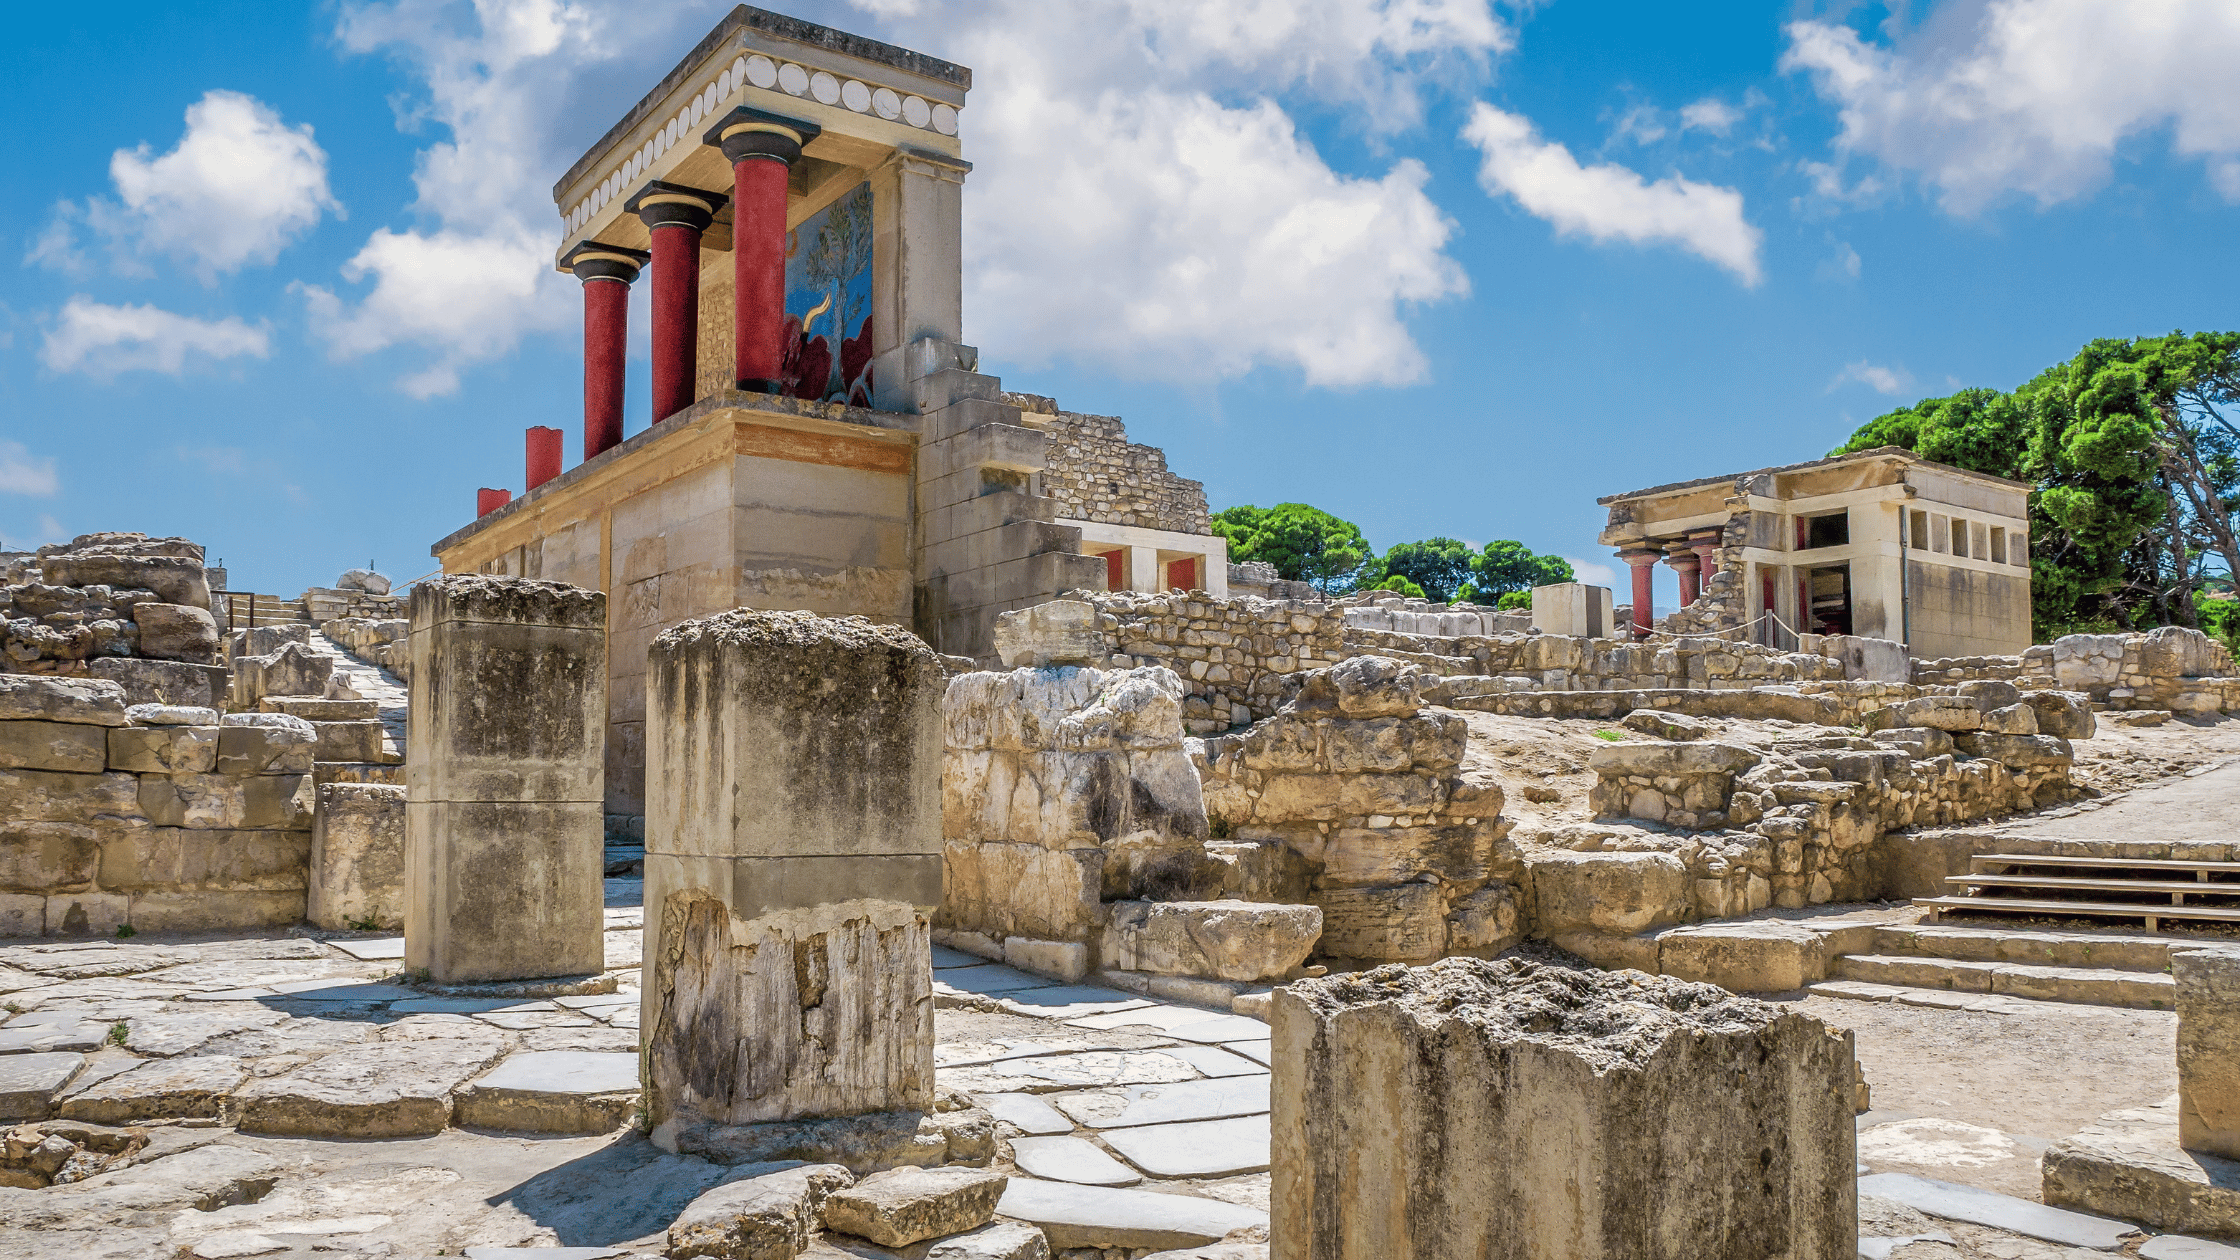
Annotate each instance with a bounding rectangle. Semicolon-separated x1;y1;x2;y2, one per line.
784;184;871;406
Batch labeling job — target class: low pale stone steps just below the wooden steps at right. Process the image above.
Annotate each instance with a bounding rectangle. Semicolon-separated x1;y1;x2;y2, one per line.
1810;924;2168;1011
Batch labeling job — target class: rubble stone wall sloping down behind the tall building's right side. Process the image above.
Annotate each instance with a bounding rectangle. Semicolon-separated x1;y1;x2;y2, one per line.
1004;392;1212;534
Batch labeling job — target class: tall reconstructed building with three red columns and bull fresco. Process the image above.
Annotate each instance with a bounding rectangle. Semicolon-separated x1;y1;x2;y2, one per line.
435;4;1228;816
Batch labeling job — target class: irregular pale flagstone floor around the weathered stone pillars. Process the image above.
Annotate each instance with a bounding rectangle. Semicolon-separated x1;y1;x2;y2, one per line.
0;879;2240;1260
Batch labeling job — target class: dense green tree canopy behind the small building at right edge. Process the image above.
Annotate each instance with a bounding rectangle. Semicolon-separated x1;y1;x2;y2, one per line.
1832;332;2240;639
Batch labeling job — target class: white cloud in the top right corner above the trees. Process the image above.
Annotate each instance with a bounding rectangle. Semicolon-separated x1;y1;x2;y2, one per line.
1781;0;2240;215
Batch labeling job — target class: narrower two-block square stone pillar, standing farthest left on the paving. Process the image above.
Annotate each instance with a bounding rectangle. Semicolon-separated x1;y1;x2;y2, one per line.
405;574;607;984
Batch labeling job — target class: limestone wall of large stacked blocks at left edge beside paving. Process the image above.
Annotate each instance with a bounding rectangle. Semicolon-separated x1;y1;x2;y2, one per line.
0;675;318;937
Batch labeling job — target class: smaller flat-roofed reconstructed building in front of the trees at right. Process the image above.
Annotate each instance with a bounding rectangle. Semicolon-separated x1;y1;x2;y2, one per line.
1595;446;2032;657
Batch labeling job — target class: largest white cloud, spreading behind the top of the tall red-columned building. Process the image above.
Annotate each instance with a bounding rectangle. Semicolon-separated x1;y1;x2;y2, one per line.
315;0;1514;395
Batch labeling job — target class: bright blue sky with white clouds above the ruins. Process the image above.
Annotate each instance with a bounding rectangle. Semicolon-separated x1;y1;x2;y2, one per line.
0;0;2240;601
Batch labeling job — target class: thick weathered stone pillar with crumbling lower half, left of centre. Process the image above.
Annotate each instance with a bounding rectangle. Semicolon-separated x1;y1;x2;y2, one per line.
643;610;948;1150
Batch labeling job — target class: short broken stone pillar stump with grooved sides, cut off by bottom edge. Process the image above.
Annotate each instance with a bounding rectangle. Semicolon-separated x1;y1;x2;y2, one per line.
1268;957;1859;1260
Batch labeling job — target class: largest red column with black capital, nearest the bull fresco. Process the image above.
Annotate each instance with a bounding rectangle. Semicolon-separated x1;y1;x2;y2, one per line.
701;105;820;395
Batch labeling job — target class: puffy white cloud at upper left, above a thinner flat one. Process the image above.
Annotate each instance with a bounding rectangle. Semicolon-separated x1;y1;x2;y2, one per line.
25;90;343;282
